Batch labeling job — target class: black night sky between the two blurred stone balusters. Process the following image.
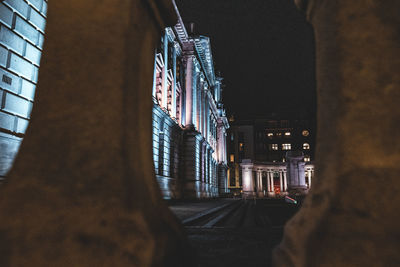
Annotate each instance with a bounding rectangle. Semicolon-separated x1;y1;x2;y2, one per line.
176;0;315;118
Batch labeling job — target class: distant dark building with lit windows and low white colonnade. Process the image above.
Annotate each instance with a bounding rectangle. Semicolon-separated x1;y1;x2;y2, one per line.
228;116;315;197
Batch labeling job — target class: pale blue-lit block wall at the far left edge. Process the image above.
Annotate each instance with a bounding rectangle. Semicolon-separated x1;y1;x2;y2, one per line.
0;0;47;179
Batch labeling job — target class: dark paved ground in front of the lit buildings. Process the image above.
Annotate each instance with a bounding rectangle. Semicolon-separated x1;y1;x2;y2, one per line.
170;199;299;267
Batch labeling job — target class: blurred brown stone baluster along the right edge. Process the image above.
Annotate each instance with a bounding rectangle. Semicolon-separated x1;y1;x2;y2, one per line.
274;0;400;267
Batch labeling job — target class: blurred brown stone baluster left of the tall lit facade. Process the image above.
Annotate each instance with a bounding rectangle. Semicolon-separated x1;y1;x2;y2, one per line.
0;0;191;266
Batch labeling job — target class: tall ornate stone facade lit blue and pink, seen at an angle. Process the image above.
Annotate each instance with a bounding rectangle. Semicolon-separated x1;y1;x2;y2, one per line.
152;2;229;198
